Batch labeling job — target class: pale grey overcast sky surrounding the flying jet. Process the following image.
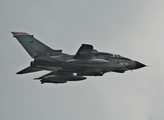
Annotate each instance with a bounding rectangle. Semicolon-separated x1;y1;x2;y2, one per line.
0;0;164;120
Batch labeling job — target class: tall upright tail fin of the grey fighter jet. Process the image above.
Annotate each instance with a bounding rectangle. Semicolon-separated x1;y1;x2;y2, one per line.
11;32;54;58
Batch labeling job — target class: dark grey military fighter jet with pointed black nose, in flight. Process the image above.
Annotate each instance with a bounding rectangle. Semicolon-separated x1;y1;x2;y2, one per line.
12;32;146;84
